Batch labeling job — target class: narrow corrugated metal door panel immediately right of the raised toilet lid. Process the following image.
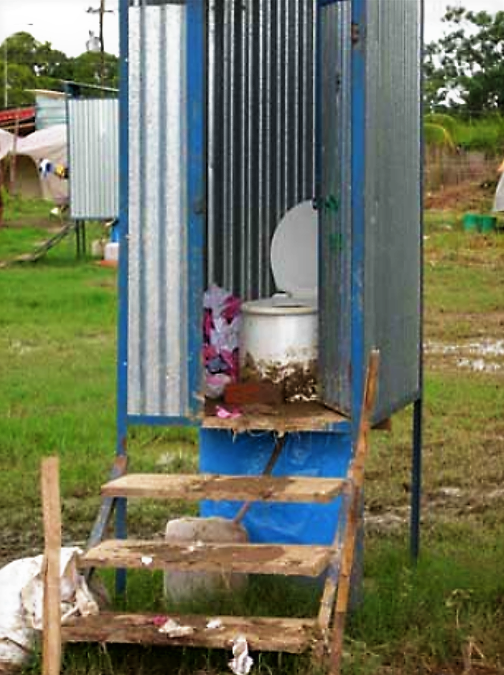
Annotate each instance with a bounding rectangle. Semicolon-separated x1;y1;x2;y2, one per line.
319;2;352;411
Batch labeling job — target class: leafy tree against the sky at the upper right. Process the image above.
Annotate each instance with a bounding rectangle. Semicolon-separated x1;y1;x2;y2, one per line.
424;6;504;113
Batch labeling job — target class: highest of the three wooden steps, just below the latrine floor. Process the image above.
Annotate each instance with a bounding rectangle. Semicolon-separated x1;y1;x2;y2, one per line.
102;474;347;504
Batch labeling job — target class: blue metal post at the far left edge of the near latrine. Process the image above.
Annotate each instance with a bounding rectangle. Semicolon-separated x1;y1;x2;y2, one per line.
115;0;129;593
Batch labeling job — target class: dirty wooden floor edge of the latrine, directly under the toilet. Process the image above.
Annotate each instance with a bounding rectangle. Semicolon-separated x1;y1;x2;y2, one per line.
202;401;349;433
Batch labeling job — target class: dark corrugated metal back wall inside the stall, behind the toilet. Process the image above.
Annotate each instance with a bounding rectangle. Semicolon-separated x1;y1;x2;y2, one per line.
208;0;316;299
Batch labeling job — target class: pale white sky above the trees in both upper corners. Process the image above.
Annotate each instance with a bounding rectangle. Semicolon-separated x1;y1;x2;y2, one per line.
0;0;504;56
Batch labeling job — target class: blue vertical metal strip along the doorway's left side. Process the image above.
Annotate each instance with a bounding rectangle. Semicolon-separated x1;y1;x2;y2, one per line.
186;0;207;416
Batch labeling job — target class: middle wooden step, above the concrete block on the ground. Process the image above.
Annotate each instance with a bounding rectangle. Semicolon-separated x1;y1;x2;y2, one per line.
80;539;334;577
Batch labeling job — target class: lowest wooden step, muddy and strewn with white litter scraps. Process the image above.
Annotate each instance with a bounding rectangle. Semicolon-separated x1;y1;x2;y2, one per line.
62;612;320;654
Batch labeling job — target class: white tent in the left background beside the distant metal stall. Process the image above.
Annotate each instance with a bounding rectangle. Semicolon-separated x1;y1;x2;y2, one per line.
0;124;68;204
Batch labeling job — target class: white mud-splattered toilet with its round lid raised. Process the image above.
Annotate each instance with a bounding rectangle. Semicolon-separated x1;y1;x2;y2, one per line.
240;201;318;401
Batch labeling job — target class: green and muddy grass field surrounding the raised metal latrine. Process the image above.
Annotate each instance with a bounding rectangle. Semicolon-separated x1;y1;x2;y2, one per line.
0;191;504;675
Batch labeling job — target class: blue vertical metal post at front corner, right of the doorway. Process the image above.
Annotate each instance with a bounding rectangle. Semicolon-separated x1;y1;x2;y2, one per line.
350;0;367;440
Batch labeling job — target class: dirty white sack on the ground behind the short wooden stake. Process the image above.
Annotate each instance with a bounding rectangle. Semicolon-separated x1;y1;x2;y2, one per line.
0;547;99;672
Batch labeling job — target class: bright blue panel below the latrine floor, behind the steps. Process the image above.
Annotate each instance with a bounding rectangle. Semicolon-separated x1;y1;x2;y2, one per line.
200;430;352;545
